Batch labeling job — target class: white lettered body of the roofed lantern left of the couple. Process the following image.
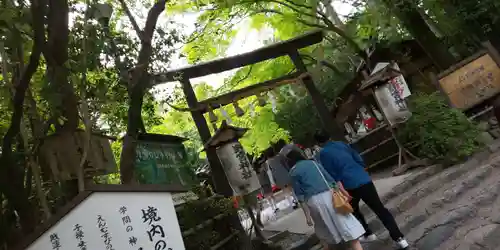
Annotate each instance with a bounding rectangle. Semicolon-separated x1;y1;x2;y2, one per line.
217;142;260;196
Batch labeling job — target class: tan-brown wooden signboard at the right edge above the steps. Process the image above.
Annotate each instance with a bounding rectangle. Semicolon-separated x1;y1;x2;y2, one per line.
438;52;500;110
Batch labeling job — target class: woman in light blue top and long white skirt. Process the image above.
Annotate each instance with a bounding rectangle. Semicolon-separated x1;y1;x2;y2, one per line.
280;147;365;250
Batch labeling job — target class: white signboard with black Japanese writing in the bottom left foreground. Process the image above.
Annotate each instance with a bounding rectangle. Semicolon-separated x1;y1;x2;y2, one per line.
27;192;185;250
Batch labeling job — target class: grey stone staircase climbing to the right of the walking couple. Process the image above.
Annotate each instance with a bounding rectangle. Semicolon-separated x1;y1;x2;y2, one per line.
312;147;500;250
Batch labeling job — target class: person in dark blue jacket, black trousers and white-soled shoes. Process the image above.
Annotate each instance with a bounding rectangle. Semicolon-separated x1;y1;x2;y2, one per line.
315;133;409;249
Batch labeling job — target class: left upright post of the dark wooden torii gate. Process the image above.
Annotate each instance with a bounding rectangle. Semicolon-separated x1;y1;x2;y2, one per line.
179;77;233;197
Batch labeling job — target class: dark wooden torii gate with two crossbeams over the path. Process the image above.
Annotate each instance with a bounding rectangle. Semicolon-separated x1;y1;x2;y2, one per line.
154;31;344;196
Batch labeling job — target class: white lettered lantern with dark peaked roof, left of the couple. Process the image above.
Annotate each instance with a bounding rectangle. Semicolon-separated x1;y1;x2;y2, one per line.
204;121;260;196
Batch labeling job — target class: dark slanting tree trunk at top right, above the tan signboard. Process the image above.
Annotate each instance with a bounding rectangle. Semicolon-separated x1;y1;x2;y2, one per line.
383;0;455;70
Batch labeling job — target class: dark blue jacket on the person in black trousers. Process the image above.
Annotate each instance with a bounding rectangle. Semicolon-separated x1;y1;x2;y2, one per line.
319;142;372;189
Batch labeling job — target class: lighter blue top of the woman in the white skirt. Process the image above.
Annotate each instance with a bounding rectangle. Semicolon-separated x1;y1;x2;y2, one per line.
289;160;335;202
